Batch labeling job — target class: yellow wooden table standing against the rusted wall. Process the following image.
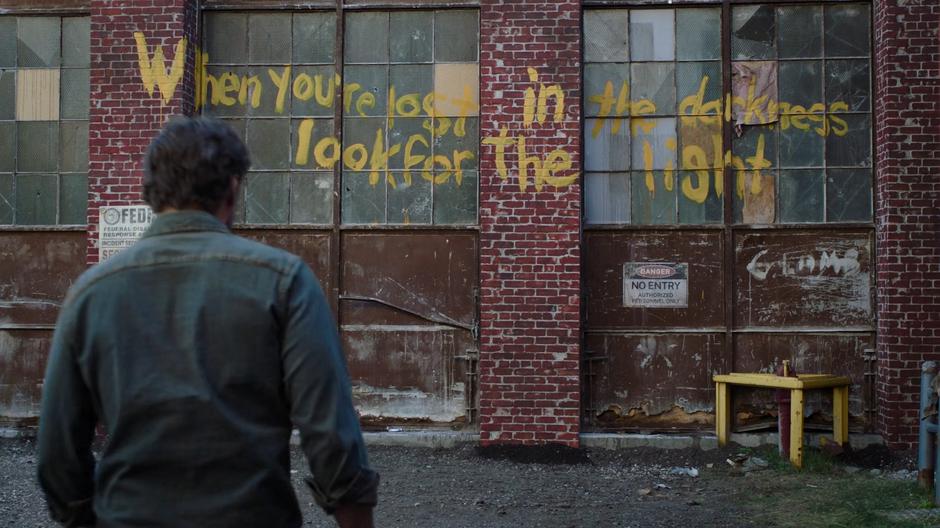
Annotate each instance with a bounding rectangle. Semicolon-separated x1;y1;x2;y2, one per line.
713;372;852;467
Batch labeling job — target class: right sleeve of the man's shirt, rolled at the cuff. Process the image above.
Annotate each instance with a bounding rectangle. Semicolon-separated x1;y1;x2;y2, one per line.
282;262;379;513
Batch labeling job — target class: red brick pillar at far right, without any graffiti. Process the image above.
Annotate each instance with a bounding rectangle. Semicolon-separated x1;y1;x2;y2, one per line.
874;0;940;448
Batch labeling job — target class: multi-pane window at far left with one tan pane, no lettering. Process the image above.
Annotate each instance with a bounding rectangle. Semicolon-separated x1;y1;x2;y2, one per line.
0;16;90;225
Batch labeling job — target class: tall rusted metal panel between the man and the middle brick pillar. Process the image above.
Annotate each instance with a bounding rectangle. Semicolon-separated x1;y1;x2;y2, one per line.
340;231;478;425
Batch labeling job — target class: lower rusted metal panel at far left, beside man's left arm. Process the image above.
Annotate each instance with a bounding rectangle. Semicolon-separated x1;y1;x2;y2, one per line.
0;330;52;428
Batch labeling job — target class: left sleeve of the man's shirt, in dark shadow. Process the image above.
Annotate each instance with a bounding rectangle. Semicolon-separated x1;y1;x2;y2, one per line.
37;303;97;526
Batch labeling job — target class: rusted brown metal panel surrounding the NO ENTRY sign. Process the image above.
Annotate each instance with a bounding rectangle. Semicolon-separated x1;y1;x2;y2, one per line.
584;231;724;332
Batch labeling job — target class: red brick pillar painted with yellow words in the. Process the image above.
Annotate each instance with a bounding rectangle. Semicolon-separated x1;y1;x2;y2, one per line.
479;0;581;446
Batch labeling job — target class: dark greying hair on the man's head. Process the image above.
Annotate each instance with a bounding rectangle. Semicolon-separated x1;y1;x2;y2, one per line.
143;117;251;213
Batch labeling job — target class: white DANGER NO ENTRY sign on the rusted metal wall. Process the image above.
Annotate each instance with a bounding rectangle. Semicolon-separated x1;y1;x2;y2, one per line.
623;262;689;308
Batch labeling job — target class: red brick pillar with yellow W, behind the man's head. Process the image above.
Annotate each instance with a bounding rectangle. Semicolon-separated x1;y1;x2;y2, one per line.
86;0;198;264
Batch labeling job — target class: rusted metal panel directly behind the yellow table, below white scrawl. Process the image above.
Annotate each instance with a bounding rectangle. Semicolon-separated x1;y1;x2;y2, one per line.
729;333;875;430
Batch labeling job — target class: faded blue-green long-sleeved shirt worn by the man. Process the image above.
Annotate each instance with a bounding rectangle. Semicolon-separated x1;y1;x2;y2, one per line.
38;211;378;528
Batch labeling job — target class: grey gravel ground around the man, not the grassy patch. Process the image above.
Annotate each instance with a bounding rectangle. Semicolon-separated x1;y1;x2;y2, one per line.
0;440;912;528
